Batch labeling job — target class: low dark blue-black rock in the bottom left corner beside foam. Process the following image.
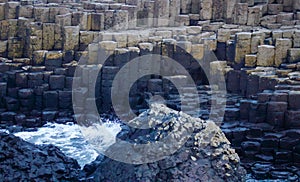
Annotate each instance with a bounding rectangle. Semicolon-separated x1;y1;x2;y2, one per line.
0;132;80;181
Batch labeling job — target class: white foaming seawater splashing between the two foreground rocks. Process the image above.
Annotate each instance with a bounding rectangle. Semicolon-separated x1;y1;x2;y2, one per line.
14;122;121;167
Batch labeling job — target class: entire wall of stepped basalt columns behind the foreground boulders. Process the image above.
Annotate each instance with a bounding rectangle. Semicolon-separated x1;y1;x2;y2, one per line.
0;0;300;178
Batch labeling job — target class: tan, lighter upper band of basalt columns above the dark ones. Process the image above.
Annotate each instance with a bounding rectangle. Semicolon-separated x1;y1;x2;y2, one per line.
0;0;300;66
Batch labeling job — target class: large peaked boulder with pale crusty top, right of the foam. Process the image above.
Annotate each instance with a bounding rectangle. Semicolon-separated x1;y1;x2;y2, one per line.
84;104;245;181
